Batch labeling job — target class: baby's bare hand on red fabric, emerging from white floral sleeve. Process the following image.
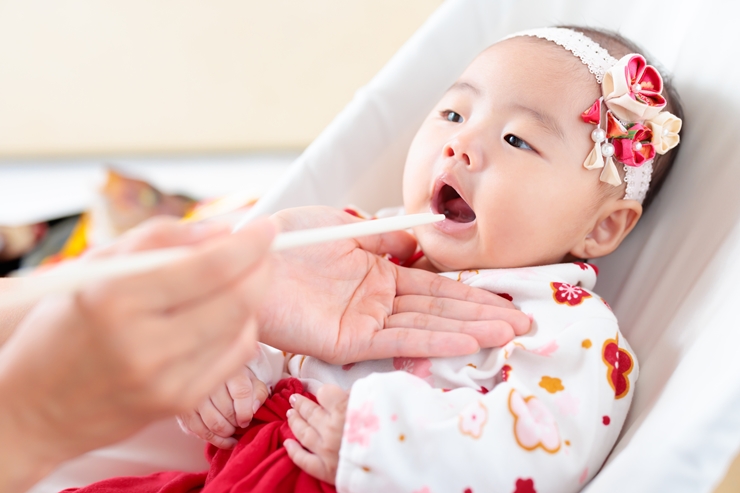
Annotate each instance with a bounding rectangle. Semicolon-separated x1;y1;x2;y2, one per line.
285;385;349;484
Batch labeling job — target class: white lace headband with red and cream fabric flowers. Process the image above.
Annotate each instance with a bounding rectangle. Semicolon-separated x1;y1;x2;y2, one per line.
505;27;681;203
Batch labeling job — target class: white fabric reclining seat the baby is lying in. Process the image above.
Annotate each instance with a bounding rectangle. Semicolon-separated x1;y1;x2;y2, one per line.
34;0;740;493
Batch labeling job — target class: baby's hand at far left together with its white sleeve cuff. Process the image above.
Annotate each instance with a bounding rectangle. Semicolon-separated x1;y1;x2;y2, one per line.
177;344;285;449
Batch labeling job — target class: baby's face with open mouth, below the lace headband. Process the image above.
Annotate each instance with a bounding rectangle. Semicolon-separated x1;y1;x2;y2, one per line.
403;38;603;271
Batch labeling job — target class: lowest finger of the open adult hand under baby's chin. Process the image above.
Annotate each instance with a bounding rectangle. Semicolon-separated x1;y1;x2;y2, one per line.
350;328;480;361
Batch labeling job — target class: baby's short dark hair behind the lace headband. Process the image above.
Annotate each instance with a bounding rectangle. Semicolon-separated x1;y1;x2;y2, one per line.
558;26;684;212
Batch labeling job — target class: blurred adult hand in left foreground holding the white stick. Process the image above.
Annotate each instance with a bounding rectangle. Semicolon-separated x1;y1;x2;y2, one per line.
0;220;275;491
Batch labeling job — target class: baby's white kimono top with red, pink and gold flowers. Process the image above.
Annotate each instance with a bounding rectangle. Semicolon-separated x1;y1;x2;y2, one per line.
249;263;638;493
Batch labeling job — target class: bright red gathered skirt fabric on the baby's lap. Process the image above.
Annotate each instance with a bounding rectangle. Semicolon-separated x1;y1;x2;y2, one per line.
64;378;336;493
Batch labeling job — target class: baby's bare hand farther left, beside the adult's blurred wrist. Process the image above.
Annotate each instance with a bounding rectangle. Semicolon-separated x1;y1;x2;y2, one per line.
177;366;269;449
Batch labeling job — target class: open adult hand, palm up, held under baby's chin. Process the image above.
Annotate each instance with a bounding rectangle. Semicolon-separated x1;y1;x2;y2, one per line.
260;207;530;364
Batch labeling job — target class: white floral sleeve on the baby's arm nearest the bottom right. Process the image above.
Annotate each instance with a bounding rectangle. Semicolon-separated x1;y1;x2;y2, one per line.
310;318;637;493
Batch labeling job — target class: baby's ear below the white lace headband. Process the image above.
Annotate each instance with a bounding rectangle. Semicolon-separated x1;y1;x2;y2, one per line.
570;199;642;258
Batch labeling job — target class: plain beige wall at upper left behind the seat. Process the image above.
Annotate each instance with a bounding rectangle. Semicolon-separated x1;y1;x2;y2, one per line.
0;0;441;158
